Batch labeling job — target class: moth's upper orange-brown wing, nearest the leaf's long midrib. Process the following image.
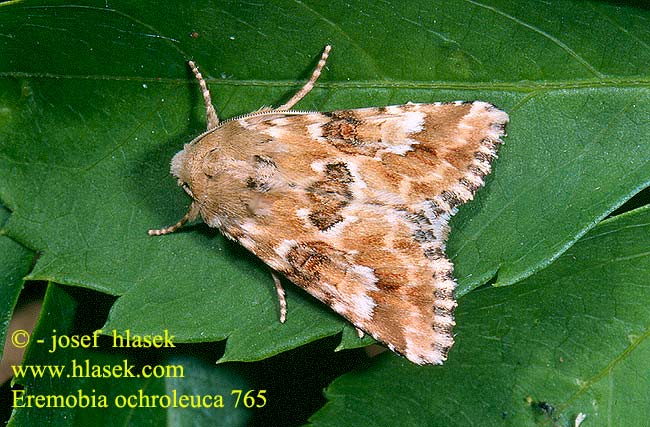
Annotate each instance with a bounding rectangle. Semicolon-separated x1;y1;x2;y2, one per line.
240;101;508;210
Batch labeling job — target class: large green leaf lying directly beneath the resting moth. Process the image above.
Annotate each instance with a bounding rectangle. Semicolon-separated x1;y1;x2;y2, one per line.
0;0;650;360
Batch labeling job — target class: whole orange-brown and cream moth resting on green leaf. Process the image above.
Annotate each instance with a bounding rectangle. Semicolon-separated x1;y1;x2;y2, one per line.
149;46;508;364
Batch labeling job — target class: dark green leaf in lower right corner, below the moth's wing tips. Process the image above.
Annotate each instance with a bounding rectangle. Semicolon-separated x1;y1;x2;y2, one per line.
311;207;650;427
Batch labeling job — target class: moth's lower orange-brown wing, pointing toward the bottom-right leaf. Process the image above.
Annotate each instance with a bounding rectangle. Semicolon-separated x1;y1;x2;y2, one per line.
260;209;456;364
